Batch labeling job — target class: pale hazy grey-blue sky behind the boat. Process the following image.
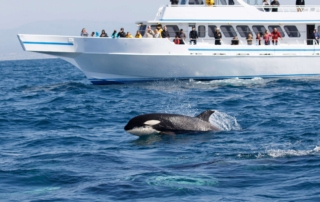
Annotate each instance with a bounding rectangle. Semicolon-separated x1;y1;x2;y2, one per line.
0;0;320;58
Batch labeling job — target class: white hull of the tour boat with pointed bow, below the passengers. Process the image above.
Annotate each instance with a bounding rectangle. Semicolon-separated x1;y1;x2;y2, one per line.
19;35;320;84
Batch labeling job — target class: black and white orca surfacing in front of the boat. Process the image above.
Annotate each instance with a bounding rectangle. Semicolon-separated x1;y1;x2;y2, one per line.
124;110;220;136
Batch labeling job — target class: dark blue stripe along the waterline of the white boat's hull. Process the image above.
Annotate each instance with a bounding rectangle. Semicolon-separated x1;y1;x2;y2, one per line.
89;74;320;85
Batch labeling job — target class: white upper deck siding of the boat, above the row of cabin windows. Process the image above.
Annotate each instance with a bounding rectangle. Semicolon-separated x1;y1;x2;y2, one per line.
137;0;320;24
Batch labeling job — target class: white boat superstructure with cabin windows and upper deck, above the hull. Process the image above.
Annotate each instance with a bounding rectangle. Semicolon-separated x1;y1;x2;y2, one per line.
138;0;320;45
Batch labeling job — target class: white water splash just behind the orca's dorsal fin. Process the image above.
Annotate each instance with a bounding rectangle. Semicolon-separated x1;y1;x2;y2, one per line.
209;111;241;131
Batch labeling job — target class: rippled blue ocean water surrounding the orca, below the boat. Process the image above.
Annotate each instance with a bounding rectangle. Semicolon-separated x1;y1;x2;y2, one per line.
0;59;320;201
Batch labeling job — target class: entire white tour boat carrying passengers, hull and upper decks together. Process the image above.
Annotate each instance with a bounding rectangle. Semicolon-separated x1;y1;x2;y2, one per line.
18;0;320;84
